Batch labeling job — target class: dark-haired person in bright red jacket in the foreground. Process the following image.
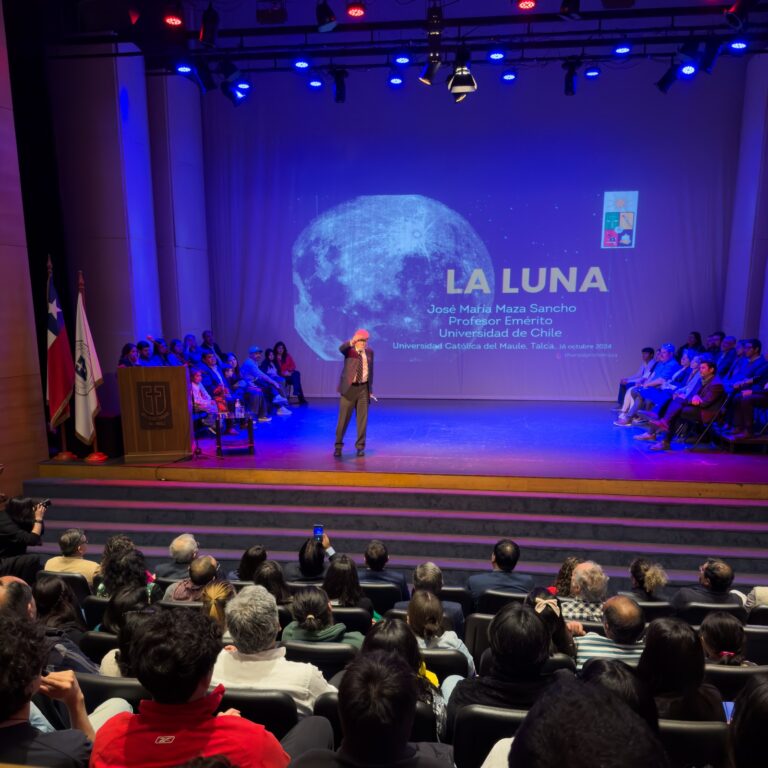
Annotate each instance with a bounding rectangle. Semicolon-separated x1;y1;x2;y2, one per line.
91;611;289;768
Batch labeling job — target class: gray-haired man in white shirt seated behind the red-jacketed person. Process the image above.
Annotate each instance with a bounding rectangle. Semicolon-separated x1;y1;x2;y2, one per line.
212;586;336;718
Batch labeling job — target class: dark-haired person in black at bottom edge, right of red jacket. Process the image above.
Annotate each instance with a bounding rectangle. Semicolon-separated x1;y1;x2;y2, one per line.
292;651;453;768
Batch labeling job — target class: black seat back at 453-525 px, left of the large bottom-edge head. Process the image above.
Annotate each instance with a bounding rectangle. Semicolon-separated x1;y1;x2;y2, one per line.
453;704;528;768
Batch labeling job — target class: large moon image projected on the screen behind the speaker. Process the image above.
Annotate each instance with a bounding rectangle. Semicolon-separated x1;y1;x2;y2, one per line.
292;195;494;360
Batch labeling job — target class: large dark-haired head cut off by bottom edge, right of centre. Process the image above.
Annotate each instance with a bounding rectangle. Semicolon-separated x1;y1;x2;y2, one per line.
509;679;670;768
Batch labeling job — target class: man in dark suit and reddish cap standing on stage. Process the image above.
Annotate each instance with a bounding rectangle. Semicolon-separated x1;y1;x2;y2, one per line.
333;328;373;457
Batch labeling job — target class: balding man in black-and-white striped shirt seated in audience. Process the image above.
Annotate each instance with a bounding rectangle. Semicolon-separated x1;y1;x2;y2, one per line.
574;595;645;670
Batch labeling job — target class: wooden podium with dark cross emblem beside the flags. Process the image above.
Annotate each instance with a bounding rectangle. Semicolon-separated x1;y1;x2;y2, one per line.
117;366;192;464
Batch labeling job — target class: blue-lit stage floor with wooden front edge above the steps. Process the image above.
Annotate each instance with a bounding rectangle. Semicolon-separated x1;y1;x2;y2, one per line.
40;398;768;500
